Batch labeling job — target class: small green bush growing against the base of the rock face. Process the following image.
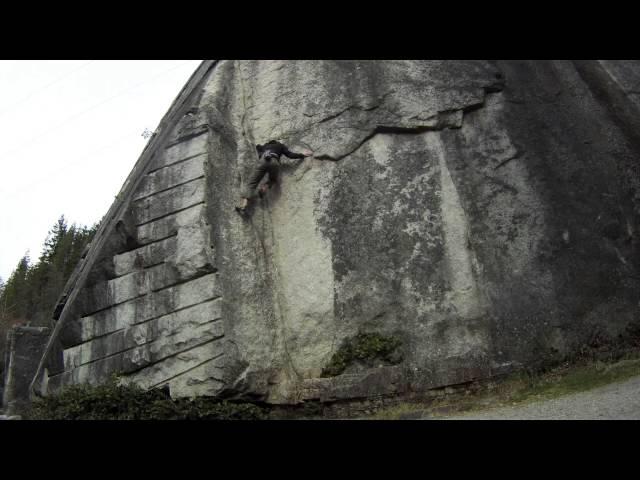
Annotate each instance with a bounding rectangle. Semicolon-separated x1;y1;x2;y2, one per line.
322;333;402;377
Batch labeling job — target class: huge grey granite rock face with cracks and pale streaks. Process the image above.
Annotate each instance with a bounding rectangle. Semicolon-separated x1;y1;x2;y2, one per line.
34;61;640;403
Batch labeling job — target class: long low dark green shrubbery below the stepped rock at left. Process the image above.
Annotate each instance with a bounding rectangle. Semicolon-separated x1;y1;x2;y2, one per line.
25;377;266;420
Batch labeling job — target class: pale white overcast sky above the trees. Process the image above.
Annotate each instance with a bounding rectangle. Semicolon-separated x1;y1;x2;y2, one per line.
0;60;200;281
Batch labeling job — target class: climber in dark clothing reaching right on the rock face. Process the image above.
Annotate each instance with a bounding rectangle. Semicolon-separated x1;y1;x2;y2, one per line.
236;140;313;216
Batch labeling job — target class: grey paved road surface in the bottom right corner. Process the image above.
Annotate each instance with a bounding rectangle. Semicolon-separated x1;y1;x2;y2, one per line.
442;376;640;420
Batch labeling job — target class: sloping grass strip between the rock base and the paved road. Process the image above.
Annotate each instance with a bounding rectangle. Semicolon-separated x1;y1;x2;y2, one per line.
369;354;640;420
